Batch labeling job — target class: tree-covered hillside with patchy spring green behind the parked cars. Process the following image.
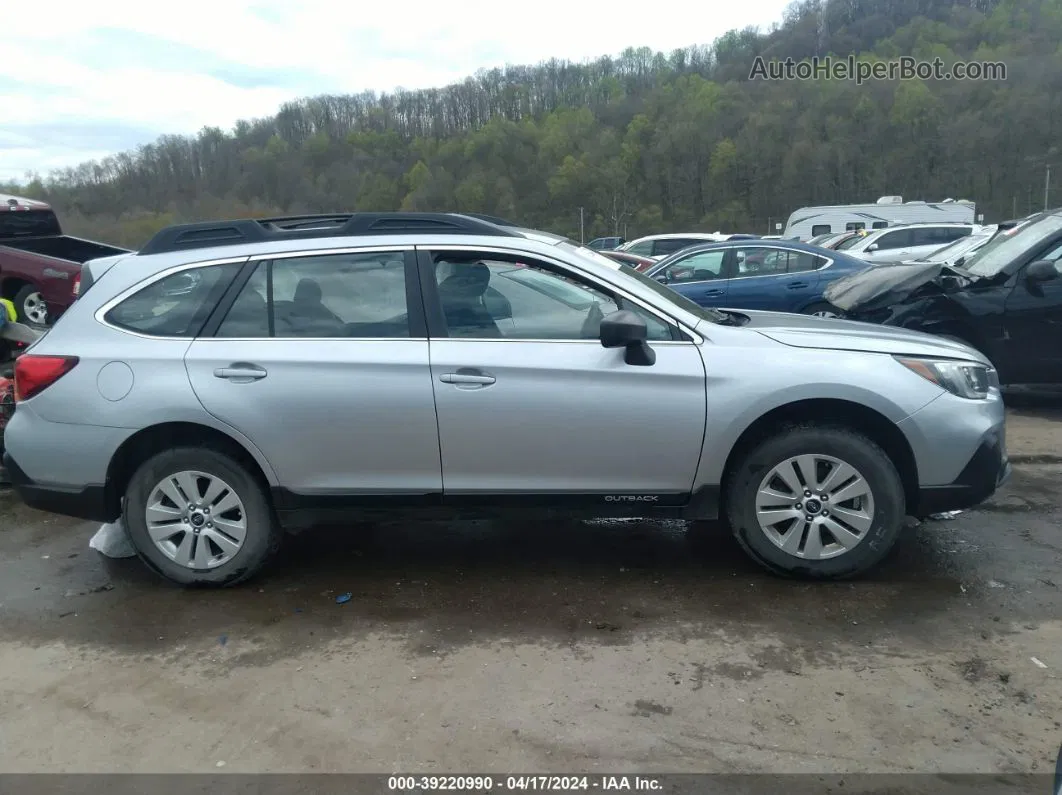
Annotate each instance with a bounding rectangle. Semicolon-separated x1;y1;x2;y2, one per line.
4;0;1062;246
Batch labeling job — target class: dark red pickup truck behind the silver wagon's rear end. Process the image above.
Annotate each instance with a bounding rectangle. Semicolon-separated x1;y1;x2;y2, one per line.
0;193;130;326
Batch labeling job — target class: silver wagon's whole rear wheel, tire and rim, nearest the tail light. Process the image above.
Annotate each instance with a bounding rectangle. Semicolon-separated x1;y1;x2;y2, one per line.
124;448;281;587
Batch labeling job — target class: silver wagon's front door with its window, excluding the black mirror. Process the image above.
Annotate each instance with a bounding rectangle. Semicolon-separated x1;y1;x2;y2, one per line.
422;249;705;507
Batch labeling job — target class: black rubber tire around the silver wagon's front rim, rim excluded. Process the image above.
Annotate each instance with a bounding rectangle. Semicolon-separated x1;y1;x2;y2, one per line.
725;425;906;580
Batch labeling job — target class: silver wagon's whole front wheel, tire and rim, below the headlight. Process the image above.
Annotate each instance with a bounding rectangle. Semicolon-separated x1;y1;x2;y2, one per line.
726;426;905;580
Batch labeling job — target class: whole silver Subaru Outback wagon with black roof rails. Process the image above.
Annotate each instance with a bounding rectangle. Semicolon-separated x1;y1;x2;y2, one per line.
4;213;1010;585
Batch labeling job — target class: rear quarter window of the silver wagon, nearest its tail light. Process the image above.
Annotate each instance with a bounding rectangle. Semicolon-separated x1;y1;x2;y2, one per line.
104;263;240;336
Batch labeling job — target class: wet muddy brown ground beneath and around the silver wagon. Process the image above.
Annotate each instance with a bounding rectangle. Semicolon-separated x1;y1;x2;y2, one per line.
0;397;1062;774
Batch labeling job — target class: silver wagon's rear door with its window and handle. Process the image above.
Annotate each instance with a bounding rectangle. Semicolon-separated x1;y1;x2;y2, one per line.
185;249;442;496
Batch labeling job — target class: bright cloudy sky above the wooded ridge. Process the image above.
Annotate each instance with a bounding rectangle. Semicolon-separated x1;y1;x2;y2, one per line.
0;0;788;180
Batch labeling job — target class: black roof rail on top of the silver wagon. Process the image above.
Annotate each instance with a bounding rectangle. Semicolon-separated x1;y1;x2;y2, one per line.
138;212;520;256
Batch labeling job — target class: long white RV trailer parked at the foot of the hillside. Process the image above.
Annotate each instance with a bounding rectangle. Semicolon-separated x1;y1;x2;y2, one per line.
782;196;976;240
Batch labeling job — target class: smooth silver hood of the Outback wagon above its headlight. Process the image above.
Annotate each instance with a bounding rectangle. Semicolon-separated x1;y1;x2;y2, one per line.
733;310;988;364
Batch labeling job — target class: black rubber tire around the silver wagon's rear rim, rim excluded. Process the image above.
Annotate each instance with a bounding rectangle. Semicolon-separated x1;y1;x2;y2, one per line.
123;447;282;587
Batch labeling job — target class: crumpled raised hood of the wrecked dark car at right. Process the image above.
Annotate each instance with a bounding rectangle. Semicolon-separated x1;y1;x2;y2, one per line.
823;262;973;312
